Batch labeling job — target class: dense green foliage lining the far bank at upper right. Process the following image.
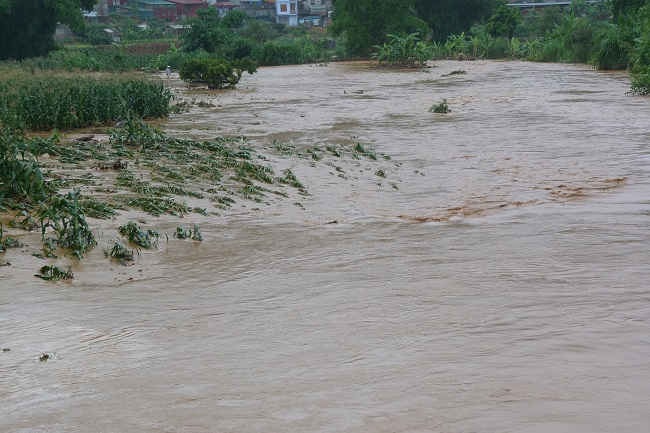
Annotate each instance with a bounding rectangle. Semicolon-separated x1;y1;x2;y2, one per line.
420;0;650;94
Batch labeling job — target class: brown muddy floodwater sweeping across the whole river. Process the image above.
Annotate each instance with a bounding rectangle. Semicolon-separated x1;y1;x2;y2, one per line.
0;62;650;433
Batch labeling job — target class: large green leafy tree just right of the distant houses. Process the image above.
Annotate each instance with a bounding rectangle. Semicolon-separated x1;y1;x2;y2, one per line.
333;0;428;55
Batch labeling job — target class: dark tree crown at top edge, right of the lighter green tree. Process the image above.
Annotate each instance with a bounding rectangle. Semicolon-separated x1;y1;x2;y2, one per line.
415;0;498;41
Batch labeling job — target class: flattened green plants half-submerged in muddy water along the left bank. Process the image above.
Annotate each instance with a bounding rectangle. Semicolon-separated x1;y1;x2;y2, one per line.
0;111;385;280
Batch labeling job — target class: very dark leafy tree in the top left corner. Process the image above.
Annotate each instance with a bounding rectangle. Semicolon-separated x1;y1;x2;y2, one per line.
0;0;95;59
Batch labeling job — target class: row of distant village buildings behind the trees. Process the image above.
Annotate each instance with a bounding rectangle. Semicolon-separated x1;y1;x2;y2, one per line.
85;0;332;27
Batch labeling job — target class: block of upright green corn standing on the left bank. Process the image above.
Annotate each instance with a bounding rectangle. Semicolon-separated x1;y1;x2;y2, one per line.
0;73;172;130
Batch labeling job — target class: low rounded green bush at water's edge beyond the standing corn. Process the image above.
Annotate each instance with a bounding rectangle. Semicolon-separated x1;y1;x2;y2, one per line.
180;58;257;89
